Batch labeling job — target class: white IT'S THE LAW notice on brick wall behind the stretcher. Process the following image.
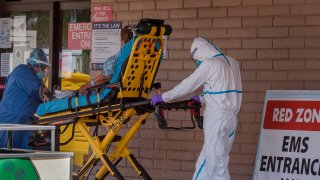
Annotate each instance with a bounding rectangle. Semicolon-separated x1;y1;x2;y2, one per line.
92;22;121;63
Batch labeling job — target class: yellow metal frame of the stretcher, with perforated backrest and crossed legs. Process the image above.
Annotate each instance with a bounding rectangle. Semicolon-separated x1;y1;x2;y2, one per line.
37;22;171;179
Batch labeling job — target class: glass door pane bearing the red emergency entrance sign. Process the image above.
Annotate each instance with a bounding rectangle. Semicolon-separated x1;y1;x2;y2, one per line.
59;2;91;90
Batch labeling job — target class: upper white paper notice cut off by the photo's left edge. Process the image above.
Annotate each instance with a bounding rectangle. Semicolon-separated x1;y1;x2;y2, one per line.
0;18;12;48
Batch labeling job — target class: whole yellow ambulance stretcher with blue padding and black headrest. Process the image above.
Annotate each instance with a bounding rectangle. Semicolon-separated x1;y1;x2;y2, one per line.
34;19;172;179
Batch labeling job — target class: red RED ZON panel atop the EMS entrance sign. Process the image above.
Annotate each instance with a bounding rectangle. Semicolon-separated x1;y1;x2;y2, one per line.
263;100;320;131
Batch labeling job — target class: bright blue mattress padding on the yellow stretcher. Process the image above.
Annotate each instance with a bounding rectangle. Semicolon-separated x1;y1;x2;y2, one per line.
37;38;135;116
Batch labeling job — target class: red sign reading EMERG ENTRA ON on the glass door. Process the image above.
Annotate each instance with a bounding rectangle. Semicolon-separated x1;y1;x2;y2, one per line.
68;23;92;50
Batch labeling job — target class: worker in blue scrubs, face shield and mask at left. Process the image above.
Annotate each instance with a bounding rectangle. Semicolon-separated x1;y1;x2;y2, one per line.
0;48;49;149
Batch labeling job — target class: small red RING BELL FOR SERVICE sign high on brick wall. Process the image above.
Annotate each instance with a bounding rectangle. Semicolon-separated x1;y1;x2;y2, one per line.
92;4;112;22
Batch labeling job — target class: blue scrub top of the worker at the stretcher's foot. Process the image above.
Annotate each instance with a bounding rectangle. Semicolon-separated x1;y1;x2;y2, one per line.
0;64;43;123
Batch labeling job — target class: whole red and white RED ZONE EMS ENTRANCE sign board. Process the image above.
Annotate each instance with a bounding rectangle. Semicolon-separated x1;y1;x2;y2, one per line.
253;91;320;180
